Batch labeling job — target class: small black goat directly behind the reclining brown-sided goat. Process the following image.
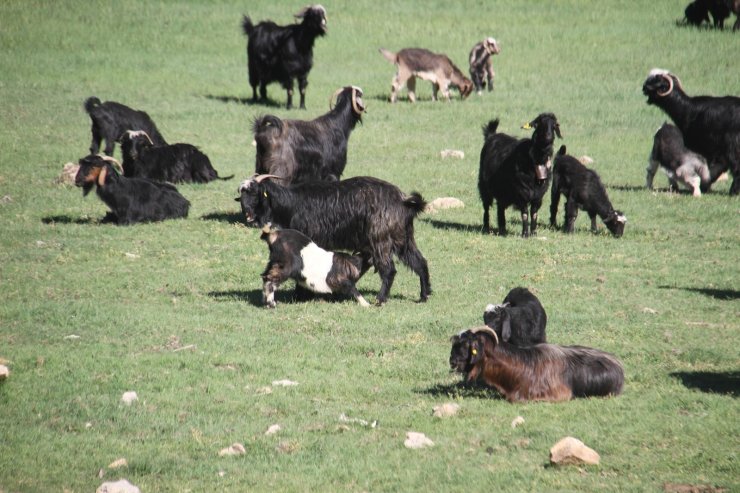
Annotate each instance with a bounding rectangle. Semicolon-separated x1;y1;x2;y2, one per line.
483;288;547;346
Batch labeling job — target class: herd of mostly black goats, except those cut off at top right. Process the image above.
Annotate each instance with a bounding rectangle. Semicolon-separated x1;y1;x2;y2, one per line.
66;5;740;401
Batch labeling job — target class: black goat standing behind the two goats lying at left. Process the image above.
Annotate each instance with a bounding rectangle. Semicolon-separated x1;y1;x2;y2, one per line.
85;96;167;156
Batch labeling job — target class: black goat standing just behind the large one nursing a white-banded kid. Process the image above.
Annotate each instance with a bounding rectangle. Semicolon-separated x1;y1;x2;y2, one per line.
252;87;365;185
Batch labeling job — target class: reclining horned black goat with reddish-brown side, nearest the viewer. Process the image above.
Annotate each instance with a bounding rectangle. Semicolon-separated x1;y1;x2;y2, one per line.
450;326;624;402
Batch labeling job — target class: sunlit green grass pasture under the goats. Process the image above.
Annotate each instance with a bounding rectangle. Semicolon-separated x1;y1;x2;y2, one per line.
0;0;740;493
